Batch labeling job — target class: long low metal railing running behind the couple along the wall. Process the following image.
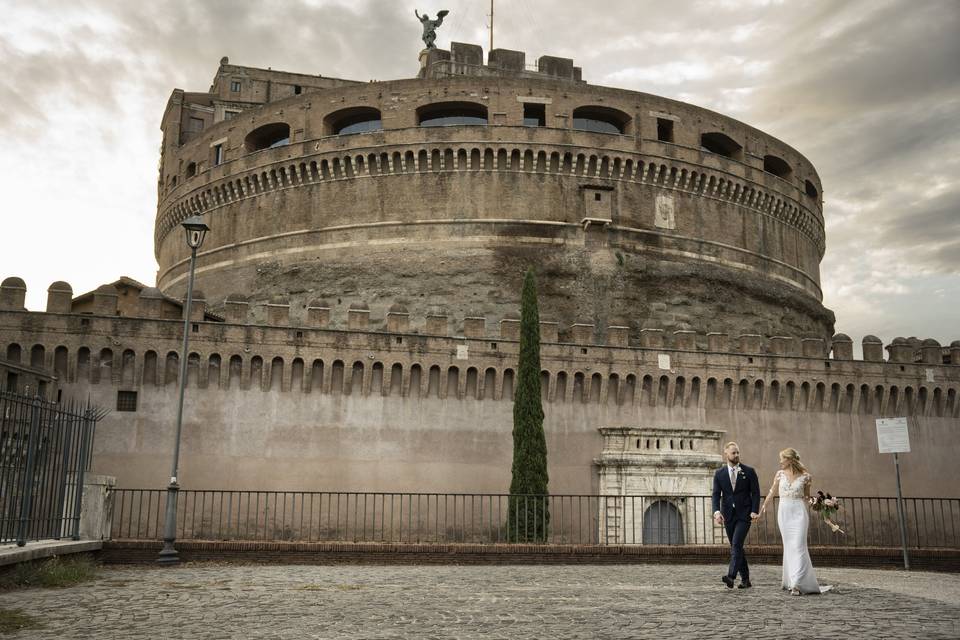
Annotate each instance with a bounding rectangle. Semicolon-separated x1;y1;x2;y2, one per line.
113;489;960;548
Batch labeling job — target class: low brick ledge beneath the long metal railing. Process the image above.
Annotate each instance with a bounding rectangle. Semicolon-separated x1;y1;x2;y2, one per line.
101;540;960;572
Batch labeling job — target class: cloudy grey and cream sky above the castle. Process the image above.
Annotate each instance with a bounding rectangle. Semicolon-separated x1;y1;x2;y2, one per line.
0;0;960;350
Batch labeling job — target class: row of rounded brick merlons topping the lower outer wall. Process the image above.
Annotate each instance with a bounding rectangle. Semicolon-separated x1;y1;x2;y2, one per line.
0;277;960;368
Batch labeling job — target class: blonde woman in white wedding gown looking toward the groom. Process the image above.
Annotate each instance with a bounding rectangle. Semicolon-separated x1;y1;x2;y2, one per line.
758;449;831;596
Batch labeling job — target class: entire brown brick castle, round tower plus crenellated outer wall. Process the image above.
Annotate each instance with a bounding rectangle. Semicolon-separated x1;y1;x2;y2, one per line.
0;43;960;496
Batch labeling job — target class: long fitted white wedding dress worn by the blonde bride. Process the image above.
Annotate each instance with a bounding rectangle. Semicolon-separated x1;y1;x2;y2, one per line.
777;471;832;593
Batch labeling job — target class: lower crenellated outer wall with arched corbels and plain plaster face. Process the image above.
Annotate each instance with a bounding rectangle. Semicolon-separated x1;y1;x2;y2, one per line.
0;279;960;495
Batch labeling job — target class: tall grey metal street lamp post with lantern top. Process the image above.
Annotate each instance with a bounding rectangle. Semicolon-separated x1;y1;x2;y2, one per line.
157;216;210;564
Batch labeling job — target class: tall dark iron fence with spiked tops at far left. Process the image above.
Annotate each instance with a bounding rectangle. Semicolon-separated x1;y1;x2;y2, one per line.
0;392;102;546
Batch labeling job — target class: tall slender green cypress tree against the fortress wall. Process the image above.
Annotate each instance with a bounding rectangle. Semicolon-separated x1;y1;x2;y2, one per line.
507;269;550;542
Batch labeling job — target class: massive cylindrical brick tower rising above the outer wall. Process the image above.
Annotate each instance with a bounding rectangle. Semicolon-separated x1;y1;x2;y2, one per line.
155;43;833;340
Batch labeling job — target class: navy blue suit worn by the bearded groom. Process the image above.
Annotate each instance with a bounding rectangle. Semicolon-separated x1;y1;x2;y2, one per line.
713;464;760;581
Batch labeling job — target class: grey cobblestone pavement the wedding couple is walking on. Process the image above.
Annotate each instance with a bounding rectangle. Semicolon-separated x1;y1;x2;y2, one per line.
0;564;960;640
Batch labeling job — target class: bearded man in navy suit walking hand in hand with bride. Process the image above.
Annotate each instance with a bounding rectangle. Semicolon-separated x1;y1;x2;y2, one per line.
713;442;760;589
